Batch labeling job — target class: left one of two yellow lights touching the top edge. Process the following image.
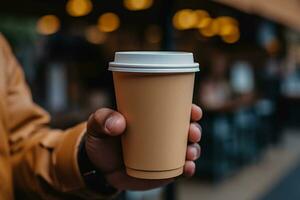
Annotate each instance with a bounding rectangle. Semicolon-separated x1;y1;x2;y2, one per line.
66;0;93;17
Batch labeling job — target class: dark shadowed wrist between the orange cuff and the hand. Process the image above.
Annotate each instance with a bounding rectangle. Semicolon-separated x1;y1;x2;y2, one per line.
77;136;118;195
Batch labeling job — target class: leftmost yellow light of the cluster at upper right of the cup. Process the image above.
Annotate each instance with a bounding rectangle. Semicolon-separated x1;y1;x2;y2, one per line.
173;9;197;30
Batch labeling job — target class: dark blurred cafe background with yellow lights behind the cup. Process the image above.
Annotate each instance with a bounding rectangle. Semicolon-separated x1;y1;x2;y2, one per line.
0;0;300;200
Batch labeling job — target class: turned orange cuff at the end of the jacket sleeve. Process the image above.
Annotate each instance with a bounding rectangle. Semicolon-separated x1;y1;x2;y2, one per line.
54;123;86;192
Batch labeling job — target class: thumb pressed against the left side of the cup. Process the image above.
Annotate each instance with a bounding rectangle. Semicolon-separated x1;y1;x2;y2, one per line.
87;108;126;138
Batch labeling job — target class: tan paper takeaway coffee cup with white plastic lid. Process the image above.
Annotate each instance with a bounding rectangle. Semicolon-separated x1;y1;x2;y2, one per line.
109;51;199;179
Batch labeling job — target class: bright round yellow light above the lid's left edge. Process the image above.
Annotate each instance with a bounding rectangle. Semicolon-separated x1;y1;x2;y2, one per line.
98;12;120;32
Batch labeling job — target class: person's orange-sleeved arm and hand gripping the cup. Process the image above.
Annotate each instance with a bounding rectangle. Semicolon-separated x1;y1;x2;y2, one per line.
0;34;202;200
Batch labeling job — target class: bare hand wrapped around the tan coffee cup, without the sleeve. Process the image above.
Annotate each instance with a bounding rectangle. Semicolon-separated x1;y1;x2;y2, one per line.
85;105;202;190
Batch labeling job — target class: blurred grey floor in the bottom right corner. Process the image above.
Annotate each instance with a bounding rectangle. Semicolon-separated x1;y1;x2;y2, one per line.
177;129;300;200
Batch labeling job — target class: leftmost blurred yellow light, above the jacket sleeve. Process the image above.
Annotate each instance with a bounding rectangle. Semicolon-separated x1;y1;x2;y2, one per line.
36;15;60;35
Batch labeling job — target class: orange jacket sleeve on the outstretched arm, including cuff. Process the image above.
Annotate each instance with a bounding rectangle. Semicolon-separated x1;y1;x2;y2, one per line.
0;34;109;200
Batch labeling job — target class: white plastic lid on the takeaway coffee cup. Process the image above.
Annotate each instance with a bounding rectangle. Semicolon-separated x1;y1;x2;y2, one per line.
108;51;199;73
